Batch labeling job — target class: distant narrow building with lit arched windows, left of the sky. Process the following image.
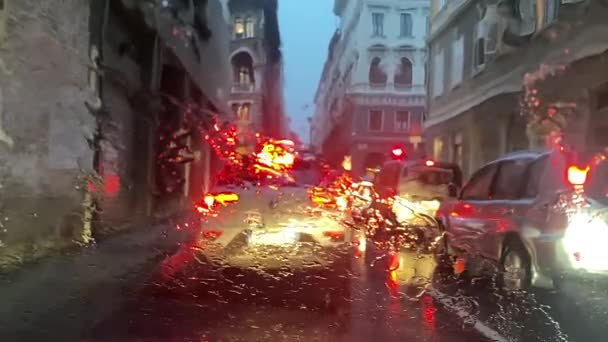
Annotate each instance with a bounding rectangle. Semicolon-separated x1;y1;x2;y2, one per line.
224;0;287;143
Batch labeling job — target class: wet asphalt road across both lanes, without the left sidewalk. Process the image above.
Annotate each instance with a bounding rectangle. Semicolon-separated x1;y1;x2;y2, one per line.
83;187;608;342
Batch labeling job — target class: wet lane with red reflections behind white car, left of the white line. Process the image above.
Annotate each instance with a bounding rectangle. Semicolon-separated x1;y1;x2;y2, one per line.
87;242;485;342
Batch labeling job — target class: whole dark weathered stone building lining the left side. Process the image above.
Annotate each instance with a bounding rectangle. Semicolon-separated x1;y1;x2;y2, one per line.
0;0;229;262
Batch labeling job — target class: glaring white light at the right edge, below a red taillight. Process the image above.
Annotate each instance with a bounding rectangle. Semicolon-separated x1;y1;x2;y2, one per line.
563;213;608;271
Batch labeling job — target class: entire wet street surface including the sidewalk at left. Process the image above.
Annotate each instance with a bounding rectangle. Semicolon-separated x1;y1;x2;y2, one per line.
0;188;608;341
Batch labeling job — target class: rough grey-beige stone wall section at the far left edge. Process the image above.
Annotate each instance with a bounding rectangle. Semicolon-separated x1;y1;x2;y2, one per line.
0;0;95;248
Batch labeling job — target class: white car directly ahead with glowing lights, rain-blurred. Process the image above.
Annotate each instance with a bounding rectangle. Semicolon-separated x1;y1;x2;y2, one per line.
196;185;354;305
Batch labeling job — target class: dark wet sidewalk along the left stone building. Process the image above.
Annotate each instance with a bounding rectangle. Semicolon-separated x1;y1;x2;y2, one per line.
0;212;197;341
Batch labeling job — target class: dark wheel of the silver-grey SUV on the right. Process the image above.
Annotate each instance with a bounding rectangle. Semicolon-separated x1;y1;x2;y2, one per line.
502;242;532;291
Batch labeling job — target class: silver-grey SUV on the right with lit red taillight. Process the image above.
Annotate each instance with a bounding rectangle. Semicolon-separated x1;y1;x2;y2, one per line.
436;149;608;291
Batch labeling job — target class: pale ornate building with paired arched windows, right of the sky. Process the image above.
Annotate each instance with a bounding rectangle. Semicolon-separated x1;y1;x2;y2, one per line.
311;0;430;175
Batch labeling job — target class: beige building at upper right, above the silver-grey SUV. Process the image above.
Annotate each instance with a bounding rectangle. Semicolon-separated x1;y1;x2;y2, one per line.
424;0;608;179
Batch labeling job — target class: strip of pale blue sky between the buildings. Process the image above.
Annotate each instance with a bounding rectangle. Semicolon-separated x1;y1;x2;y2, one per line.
279;0;337;142
